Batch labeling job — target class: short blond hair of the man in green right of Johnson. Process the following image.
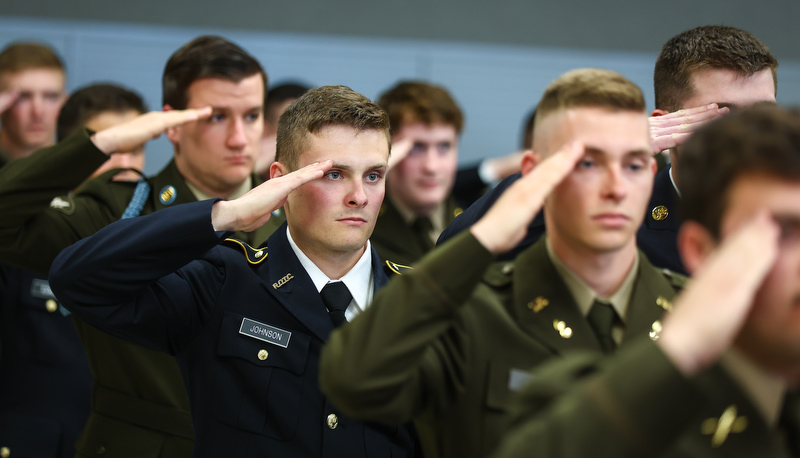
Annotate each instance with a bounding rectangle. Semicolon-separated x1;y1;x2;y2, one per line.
534;68;645;130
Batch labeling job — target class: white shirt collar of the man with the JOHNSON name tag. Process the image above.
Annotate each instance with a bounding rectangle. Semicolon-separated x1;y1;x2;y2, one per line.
286;226;375;321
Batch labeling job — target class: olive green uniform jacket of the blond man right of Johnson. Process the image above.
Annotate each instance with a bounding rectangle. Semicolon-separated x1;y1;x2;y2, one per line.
320;231;683;458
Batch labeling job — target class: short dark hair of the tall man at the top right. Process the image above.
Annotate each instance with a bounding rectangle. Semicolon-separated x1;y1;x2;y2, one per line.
653;25;778;111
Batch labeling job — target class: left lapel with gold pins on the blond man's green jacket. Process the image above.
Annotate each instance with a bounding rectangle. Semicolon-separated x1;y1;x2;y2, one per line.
513;239;601;354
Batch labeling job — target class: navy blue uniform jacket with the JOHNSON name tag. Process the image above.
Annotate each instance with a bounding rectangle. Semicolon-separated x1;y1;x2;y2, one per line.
50;200;413;458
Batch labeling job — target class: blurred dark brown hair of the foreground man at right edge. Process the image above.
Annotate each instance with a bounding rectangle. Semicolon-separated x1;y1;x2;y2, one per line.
677;103;800;238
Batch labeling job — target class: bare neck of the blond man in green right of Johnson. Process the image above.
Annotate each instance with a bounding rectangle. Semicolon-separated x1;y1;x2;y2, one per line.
547;232;636;297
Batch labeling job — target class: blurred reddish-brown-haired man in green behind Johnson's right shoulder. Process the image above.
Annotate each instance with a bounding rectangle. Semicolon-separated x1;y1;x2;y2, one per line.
370;81;464;265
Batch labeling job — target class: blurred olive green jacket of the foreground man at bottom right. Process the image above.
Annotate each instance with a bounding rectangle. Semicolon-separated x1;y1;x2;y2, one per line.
492;339;800;458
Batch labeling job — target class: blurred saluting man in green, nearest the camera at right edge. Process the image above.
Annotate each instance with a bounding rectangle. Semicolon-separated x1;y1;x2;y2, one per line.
493;105;800;458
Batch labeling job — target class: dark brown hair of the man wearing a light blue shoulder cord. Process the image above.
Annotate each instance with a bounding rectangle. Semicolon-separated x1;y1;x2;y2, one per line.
161;35;267;110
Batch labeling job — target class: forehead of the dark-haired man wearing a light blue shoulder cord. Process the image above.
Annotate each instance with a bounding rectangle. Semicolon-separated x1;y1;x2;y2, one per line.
186;73;264;109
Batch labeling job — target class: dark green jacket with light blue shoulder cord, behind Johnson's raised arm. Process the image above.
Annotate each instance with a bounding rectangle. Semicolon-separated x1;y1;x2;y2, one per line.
0;130;283;457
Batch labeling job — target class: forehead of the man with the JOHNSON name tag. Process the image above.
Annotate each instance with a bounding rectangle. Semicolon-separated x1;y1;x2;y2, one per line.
299;124;389;167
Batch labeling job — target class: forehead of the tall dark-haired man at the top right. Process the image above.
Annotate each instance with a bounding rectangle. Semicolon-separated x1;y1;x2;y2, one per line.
683;68;775;108
